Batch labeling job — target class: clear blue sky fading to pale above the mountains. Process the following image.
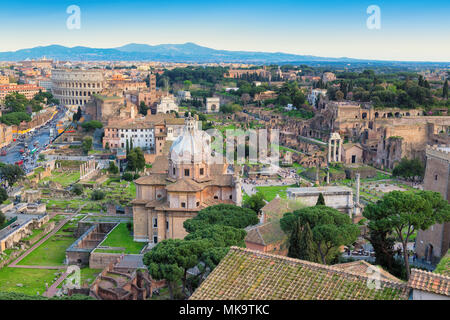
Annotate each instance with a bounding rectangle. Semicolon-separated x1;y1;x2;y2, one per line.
0;0;450;61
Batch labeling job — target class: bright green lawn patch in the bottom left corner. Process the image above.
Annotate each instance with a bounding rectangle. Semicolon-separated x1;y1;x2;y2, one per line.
0;267;58;295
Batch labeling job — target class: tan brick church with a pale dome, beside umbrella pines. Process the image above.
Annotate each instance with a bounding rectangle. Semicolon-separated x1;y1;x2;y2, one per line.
132;114;242;244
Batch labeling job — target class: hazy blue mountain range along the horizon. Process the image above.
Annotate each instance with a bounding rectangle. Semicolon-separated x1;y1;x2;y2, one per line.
0;42;446;64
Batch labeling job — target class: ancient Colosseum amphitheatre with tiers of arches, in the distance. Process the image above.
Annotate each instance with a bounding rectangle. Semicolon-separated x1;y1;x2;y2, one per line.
52;69;105;107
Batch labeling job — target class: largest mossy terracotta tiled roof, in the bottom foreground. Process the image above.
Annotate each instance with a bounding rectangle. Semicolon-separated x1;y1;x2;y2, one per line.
191;247;409;300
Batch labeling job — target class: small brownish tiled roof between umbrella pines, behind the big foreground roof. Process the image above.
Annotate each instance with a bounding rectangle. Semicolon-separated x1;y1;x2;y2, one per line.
245;220;287;246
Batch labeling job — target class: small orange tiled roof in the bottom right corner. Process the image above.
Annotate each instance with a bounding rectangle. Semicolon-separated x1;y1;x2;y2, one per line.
408;269;450;296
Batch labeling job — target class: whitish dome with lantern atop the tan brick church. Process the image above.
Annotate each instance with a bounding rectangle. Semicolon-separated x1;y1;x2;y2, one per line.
170;115;211;163
